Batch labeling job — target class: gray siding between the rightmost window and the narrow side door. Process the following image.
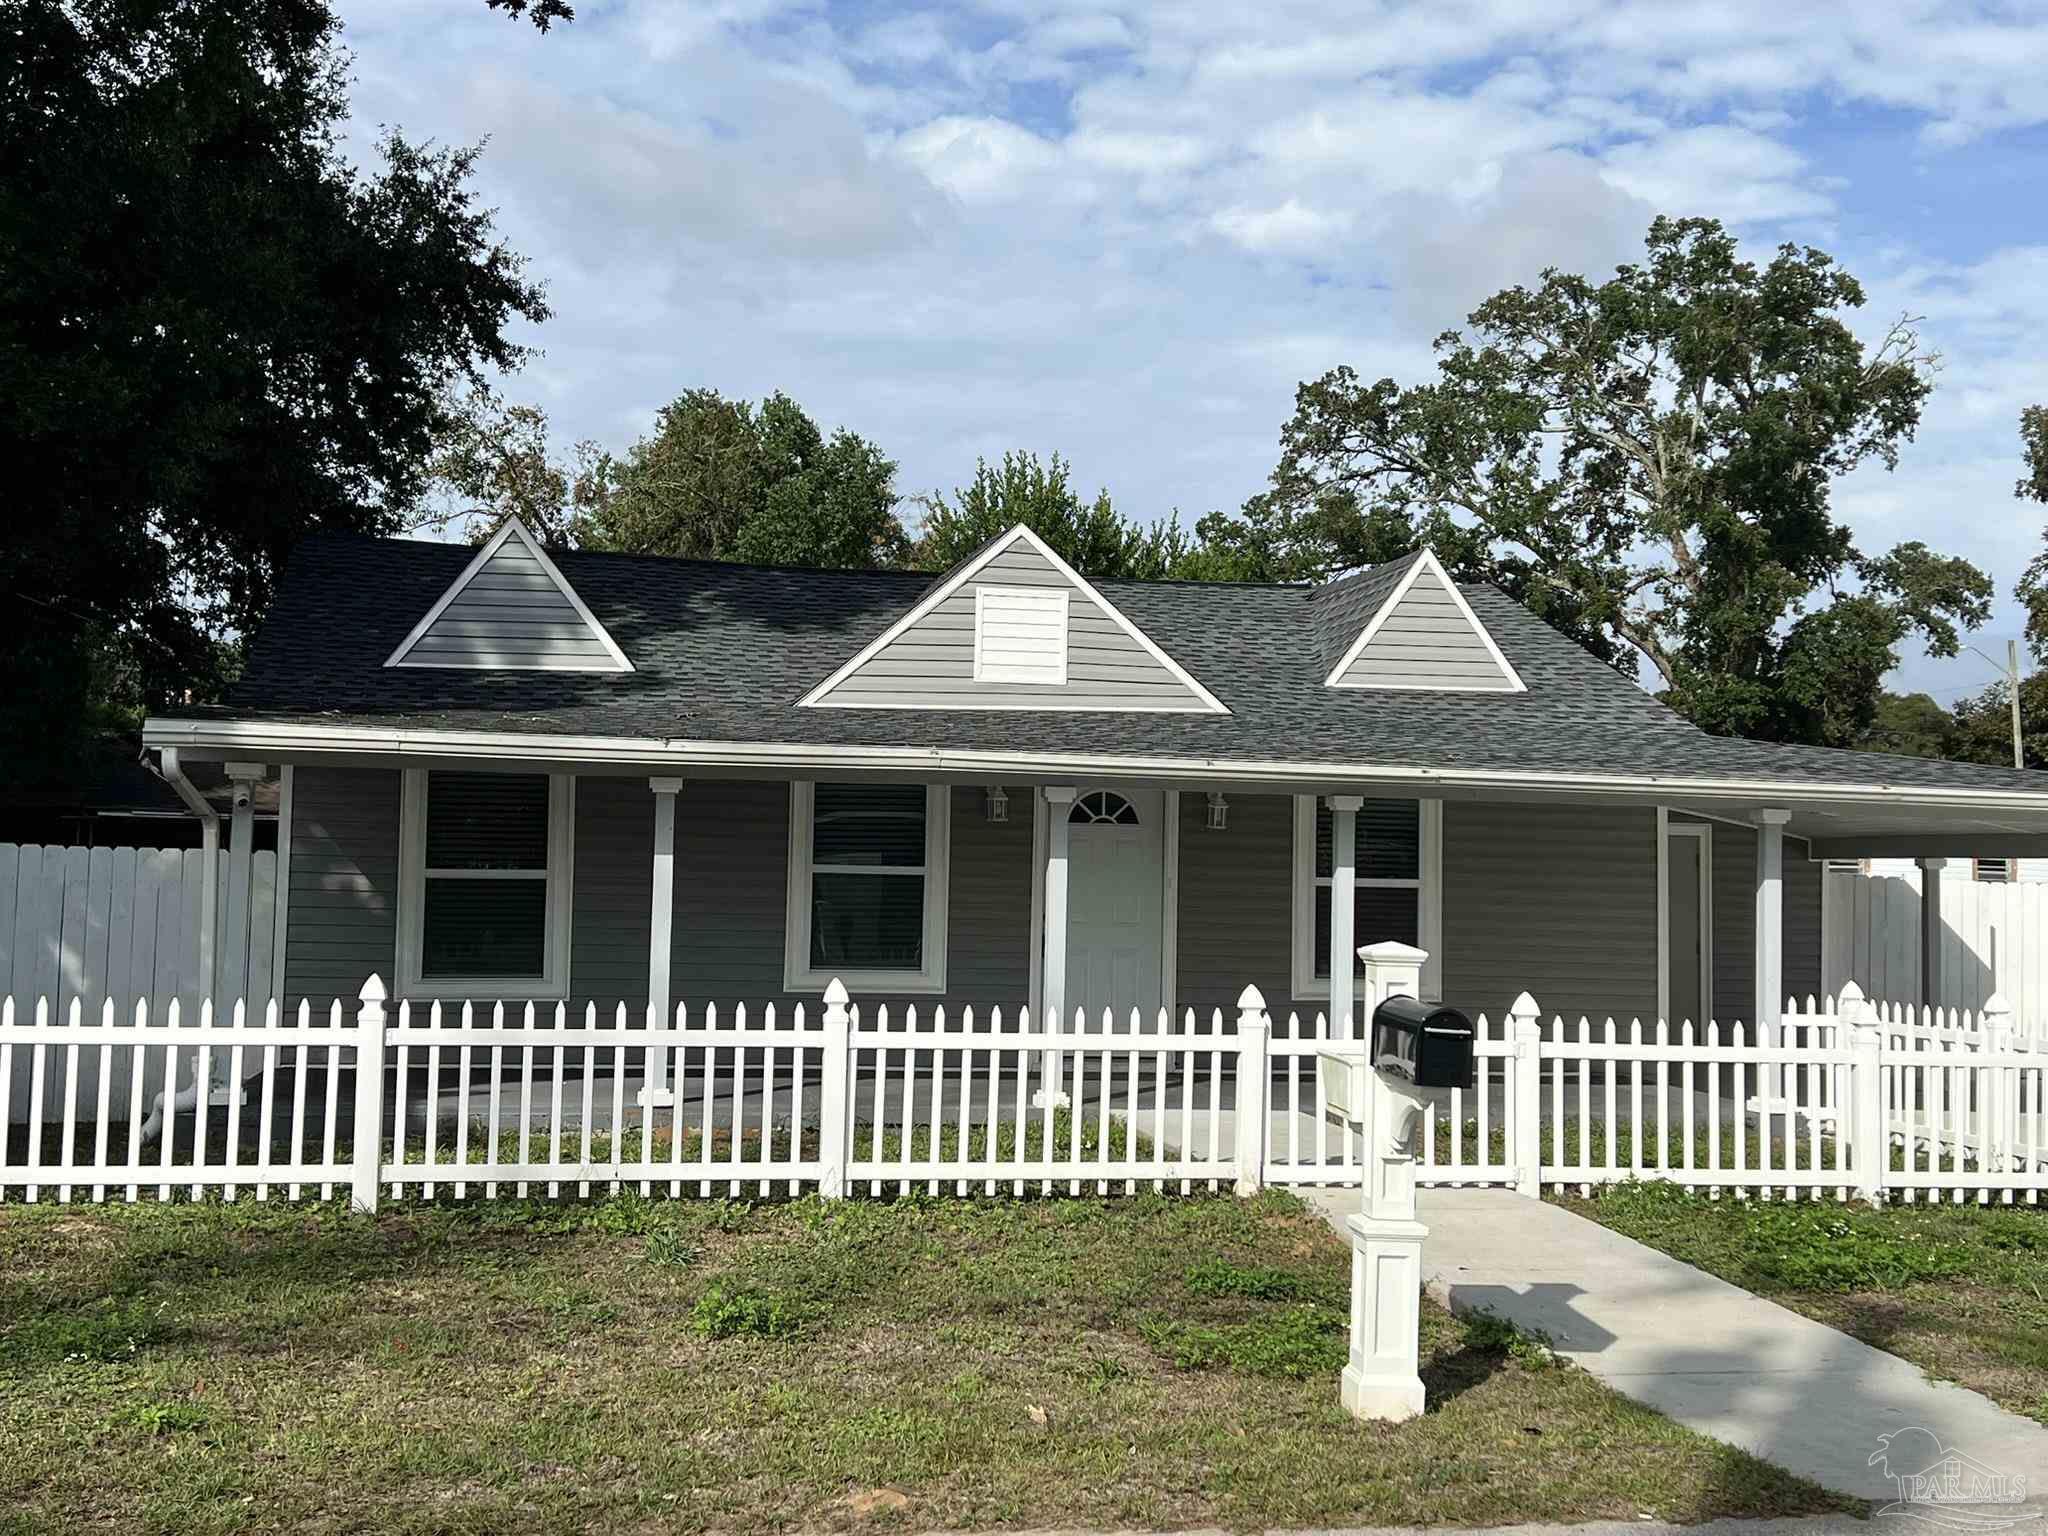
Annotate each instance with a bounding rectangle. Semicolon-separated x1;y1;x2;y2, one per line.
1444;801;1657;1026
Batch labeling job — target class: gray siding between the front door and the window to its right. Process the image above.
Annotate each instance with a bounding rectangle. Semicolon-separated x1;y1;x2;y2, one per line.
1174;793;1294;1028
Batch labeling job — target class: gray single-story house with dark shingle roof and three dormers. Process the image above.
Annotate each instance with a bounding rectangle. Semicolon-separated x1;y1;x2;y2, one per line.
145;522;2048;1073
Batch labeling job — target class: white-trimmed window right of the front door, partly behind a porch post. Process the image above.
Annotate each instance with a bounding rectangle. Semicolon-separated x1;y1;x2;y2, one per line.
1294;795;1444;997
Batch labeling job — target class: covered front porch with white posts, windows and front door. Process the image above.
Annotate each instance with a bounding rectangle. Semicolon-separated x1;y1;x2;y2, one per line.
180;741;2015;1036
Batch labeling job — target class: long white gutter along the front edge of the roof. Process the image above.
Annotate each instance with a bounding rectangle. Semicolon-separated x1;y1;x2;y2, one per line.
143;719;2048;817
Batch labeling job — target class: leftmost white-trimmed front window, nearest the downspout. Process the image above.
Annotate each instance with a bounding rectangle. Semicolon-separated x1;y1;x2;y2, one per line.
397;768;575;997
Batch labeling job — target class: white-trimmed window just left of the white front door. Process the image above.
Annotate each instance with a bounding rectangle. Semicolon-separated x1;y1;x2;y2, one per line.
782;782;950;991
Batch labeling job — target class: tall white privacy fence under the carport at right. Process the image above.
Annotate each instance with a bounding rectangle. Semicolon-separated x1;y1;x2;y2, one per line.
1821;872;2048;1038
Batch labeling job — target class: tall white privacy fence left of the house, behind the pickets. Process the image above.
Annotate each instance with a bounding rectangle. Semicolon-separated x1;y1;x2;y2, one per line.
0;844;276;1122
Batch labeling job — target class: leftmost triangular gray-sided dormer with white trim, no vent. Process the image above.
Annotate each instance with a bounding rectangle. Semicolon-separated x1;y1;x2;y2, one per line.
385;518;633;672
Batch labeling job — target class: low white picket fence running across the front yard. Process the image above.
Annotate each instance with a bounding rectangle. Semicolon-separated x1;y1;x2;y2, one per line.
0;977;2048;1208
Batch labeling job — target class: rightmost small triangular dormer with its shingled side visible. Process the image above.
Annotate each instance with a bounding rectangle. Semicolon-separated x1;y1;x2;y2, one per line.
1323;549;1528;694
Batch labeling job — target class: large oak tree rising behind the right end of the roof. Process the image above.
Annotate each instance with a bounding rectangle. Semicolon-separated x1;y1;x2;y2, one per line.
1228;219;1991;745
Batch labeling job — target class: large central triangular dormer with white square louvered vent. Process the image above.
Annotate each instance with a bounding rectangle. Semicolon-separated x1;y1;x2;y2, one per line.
801;522;1229;715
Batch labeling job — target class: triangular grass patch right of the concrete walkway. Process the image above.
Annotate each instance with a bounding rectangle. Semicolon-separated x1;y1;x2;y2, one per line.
1563;1184;2048;1423
